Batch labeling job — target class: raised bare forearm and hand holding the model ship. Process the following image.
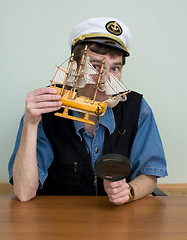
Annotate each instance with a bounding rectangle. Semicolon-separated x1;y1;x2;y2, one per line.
13;87;62;202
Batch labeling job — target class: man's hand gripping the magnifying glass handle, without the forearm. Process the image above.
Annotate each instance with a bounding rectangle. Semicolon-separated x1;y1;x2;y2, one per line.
104;179;130;205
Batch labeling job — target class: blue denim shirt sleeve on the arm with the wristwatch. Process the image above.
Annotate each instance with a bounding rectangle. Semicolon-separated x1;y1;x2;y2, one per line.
130;98;168;179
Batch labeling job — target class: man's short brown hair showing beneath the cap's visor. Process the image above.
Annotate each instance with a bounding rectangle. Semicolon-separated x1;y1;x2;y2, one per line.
73;42;126;65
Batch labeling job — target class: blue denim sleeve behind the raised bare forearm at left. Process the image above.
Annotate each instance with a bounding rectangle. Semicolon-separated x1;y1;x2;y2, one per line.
8;116;54;189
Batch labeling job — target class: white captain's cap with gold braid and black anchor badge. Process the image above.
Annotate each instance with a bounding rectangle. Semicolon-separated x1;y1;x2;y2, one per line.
70;17;131;57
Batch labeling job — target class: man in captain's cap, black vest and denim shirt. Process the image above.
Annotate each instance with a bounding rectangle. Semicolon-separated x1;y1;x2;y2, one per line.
9;18;167;205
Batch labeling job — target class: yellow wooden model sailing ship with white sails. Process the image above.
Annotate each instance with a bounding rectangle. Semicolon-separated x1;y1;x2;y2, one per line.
50;46;130;125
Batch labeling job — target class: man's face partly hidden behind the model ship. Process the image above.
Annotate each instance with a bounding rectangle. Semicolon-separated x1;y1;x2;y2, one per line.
78;49;123;102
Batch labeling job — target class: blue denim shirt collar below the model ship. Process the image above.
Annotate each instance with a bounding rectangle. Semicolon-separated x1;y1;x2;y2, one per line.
73;107;116;140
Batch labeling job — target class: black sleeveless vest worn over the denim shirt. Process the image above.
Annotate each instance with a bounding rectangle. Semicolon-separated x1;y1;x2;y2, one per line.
37;92;142;195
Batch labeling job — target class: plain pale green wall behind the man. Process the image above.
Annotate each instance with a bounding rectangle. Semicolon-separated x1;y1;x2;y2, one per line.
0;0;187;183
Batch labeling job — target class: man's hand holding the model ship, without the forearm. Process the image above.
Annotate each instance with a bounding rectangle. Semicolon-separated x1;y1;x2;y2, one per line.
25;87;62;124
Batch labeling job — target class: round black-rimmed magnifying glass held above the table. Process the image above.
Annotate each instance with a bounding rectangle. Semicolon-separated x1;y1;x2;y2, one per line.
95;153;132;182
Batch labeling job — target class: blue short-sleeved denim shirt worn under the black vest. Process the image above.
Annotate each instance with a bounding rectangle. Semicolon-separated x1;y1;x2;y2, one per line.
8;98;167;188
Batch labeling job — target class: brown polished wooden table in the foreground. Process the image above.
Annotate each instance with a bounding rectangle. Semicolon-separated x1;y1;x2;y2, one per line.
0;194;187;240
